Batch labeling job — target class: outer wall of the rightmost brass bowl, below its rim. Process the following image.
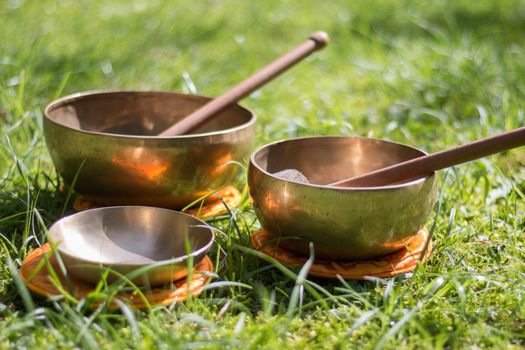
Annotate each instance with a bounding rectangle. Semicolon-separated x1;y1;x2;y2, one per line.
248;137;437;260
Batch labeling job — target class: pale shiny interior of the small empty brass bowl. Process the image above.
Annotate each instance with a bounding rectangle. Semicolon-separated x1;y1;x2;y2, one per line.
49;207;213;266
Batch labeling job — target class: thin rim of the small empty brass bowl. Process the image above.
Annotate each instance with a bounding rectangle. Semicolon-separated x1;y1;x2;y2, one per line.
47;205;215;268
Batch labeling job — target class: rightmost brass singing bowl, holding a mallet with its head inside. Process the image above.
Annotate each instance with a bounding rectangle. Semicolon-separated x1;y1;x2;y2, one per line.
248;137;437;260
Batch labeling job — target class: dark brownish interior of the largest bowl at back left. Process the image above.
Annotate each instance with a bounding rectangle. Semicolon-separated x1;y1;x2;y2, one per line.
46;91;254;136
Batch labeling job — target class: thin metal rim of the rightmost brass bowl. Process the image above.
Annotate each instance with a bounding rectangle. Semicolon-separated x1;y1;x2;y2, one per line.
250;135;435;191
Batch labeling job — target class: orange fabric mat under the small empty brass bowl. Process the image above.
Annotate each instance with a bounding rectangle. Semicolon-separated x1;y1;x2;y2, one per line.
19;244;213;308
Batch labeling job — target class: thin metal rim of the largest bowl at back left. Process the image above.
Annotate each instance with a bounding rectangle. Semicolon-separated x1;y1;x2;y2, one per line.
44;90;257;140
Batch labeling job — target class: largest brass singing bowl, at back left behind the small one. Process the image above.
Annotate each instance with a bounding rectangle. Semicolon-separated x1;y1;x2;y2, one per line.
43;91;256;209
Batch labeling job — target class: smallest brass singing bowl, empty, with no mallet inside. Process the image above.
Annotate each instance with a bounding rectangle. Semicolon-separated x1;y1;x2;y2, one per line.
48;206;214;286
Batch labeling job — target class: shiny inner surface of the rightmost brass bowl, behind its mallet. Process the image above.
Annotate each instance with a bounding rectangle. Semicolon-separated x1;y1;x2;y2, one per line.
252;137;425;185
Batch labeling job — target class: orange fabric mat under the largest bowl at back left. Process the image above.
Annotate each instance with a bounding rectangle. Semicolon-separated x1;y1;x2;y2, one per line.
73;186;242;219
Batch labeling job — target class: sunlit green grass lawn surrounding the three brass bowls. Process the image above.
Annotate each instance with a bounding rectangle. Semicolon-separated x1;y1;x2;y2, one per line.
0;0;525;349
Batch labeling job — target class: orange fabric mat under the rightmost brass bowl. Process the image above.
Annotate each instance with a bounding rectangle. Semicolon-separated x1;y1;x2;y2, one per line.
251;228;432;280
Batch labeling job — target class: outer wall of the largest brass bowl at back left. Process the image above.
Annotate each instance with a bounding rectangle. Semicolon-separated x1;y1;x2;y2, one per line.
43;92;256;209
